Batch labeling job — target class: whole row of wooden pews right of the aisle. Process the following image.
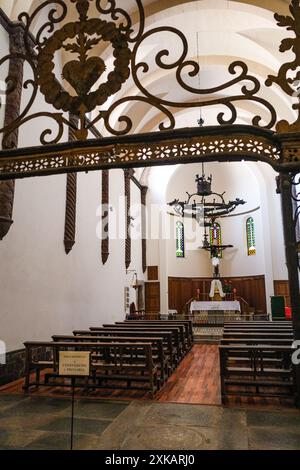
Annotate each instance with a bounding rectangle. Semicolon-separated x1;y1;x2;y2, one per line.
219;321;296;403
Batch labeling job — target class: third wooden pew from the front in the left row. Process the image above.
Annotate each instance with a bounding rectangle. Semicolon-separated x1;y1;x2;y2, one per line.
73;328;177;375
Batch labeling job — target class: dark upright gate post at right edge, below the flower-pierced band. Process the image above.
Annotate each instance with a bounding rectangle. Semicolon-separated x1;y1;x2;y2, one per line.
278;173;300;406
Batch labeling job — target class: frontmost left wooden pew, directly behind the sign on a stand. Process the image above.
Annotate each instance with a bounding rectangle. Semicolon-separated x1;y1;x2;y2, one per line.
24;341;159;396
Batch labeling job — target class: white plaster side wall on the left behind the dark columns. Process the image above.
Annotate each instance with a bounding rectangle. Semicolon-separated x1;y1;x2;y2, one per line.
0;22;143;351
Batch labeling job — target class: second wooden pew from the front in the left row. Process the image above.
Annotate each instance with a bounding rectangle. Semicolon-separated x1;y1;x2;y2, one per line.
52;335;170;385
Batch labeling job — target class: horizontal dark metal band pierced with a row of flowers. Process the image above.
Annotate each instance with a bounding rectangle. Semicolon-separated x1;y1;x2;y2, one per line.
0;125;284;179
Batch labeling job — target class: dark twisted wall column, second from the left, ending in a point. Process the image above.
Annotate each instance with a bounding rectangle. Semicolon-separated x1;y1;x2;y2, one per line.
64;115;79;254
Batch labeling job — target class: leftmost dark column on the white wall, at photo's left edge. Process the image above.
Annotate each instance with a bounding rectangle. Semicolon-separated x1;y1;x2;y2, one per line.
0;16;25;240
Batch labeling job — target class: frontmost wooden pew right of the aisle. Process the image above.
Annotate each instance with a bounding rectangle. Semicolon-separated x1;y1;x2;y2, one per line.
219;345;295;403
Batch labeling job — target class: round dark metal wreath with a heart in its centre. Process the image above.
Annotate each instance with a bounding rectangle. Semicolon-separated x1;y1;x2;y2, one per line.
37;18;131;115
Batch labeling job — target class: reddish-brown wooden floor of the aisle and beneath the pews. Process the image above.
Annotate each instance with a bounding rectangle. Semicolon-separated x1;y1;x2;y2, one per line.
0;344;294;408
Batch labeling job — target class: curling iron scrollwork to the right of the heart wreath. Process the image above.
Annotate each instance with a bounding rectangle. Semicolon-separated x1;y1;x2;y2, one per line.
100;40;276;135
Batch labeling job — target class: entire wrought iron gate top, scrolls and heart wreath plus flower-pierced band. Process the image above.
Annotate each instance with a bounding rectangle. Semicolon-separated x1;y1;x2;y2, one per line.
0;0;300;179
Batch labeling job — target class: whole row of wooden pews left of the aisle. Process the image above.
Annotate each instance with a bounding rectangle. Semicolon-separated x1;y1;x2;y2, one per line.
24;320;193;395
